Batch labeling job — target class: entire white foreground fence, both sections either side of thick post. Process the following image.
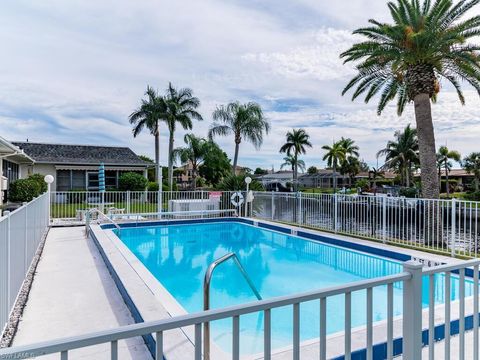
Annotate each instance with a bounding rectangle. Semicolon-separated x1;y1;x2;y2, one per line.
0;260;480;360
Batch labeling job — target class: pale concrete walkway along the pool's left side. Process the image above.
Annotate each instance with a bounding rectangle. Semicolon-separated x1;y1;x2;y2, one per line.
13;227;151;359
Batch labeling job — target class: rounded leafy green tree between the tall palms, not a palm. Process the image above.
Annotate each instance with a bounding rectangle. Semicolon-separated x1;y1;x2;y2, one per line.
199;141;232;186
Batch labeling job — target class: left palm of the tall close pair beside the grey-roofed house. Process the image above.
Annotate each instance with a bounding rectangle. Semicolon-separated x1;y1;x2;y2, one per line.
129;86;166;186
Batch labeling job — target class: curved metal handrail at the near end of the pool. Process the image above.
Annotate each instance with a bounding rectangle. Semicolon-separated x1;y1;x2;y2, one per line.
203;252;262;360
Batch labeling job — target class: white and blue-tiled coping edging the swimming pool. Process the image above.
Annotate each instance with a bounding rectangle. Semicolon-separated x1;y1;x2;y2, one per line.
91;217;473;360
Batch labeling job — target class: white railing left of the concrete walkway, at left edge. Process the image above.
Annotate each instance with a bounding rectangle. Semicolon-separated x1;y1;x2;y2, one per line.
0;193;49;334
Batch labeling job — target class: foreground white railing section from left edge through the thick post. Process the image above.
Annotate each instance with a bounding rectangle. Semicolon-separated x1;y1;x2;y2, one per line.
0;263;422;360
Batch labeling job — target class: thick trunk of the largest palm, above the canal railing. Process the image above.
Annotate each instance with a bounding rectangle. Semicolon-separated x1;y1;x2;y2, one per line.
413;94;439;199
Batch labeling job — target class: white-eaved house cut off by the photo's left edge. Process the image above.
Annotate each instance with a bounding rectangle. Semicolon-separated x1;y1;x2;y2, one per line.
0;137;34;205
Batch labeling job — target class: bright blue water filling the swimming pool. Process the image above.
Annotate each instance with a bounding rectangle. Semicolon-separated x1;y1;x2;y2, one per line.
116;222;472;354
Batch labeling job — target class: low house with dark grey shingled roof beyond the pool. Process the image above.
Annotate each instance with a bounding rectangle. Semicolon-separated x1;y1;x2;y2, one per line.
12;142;152;191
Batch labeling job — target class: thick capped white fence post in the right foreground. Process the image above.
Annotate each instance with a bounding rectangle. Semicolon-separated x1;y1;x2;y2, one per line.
403;260;423;360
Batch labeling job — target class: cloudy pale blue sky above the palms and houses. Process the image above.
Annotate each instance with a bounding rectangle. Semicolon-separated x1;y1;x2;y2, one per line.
0;0;480;170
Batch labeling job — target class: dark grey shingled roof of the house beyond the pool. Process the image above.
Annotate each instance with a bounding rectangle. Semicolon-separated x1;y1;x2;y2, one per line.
12;141;151;167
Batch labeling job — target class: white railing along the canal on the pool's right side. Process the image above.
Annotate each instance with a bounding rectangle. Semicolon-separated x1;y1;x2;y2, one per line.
251;192;480;257
